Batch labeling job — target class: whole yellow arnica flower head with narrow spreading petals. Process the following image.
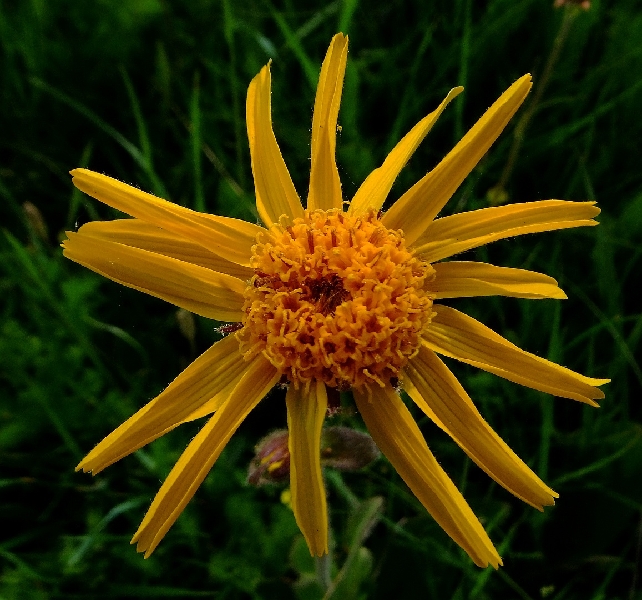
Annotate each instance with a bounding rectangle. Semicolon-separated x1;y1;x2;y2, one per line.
63;34;608;567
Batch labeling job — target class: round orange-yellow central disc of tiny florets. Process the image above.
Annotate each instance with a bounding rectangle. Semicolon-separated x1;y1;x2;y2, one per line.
236;210;434;389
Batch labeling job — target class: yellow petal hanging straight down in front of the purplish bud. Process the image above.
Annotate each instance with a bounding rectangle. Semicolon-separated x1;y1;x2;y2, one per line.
285;381;328;556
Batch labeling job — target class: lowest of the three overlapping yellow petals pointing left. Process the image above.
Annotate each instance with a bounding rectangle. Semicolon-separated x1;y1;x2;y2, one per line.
62;231;245;321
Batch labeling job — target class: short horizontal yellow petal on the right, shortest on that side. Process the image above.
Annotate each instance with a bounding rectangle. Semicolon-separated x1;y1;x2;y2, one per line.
426;261;566;300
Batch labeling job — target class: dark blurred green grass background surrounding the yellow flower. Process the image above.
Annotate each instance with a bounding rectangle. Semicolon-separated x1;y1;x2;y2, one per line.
0;0;642;600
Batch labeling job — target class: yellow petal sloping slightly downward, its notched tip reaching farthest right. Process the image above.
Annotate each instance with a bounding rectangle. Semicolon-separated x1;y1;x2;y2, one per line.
423;305;610;406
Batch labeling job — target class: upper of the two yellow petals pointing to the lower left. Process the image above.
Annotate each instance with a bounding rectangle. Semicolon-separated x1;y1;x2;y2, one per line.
76;336;248;475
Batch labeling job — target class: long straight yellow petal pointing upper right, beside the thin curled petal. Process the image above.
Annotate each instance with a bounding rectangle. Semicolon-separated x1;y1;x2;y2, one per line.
383;75;532;245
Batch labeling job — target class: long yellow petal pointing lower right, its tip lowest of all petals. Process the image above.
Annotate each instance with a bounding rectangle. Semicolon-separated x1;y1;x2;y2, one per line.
354;387;502;568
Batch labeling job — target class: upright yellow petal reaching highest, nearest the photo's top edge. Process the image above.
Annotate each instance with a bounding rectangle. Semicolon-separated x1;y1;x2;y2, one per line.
308;33;348;210
